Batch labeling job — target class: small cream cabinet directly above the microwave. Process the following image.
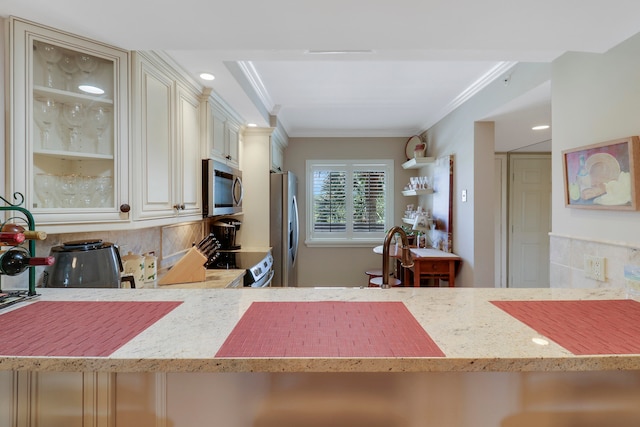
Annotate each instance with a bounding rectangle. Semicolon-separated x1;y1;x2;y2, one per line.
202;94;240;169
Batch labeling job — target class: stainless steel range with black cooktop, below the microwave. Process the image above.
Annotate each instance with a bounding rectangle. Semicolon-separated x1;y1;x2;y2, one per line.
205;250;273;288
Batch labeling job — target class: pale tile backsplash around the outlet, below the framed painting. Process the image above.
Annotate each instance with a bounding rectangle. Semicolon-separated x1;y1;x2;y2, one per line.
549;234;640;289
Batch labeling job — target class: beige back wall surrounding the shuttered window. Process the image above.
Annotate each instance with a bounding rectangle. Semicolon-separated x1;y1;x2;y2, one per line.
284;137;416;286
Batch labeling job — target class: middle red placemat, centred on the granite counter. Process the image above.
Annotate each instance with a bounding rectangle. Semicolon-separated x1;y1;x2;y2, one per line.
216;301;444;357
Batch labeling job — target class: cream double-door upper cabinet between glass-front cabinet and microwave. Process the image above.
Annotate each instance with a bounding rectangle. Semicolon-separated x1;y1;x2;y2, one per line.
132;52;202;220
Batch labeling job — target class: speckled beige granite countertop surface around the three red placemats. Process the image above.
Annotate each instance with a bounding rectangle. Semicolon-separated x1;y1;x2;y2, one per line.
0;288;640;372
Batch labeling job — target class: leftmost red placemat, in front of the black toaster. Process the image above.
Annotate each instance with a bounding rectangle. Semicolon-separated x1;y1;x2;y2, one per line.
0;301;181;357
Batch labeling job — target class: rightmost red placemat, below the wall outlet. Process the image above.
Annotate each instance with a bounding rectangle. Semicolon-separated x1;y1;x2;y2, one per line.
491;300;640;355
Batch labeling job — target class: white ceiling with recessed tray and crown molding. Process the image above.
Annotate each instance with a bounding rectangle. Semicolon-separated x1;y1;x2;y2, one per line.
0;0;640;151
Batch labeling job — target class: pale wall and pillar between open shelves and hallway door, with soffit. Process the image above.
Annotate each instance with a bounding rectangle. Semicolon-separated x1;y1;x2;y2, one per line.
427;63;551;287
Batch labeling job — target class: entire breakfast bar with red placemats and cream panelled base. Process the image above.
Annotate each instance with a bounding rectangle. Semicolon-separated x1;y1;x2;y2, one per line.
0;287;640;427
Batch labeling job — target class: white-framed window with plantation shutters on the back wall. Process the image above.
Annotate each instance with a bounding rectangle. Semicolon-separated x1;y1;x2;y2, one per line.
307;160;393;245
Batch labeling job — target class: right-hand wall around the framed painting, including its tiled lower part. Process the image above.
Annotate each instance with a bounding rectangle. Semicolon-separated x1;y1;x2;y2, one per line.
551;34;640;287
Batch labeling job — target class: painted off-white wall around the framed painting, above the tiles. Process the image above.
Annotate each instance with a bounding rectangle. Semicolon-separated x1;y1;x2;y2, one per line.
552;34;640;245
